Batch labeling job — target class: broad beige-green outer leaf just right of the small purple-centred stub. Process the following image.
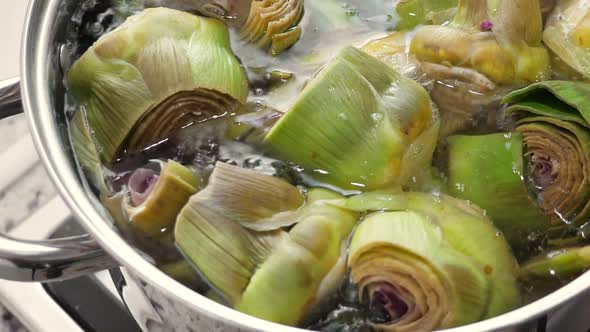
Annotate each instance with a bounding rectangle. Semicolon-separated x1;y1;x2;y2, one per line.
174;197;286;304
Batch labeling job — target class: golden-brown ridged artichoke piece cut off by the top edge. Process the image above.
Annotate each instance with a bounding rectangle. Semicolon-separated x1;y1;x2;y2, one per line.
241;0;304;55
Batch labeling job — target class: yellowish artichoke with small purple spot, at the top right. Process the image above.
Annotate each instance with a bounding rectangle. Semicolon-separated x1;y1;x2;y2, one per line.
410;0;550;137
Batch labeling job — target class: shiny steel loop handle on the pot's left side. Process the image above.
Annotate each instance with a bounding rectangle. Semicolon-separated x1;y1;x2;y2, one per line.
0;78;118;282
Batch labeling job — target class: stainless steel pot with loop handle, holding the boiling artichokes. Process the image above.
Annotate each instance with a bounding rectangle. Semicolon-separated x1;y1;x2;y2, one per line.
0;0;590;332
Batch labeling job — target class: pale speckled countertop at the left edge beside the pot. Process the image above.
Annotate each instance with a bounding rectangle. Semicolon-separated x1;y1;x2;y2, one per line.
0;0;56;332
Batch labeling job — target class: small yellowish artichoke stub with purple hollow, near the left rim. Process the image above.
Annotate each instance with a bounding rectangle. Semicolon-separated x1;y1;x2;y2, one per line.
102;160;199;239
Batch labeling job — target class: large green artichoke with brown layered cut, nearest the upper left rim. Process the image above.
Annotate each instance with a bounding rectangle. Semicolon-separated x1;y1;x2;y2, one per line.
67;8;248;165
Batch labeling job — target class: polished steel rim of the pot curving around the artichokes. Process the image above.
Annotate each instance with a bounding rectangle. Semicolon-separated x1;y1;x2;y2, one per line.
12;0;590;332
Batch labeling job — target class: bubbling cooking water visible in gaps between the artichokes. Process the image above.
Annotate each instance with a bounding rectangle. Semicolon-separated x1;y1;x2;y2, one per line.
61;0;588;331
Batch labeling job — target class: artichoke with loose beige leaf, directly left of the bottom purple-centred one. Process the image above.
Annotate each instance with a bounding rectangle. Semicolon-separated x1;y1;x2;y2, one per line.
175;164;358;325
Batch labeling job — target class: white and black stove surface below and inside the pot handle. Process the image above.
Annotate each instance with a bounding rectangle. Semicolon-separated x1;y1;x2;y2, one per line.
0;197;142;332
